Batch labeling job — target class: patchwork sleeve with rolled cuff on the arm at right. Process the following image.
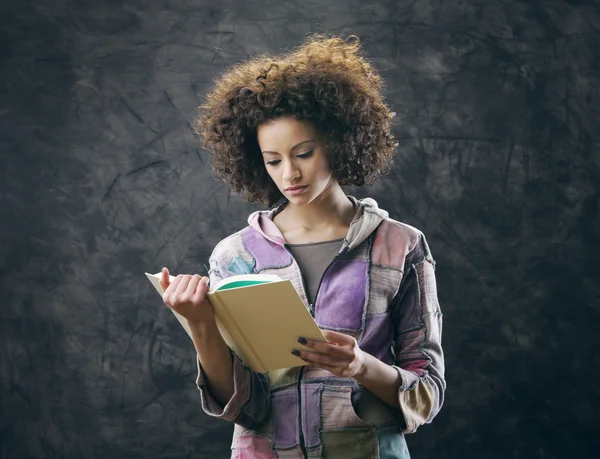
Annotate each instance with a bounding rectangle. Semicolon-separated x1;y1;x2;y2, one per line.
392;235;446;434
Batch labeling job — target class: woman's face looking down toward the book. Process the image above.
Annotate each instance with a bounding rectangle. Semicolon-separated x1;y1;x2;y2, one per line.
257;117;337;205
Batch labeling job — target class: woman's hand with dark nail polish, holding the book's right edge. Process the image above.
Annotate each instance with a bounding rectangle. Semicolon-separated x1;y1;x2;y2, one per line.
292;330;366;378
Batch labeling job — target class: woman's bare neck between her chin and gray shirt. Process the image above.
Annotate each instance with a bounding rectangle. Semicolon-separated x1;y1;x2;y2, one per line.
278;183;355;231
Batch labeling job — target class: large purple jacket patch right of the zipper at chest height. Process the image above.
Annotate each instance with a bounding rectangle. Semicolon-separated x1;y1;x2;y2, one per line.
315;260;368;331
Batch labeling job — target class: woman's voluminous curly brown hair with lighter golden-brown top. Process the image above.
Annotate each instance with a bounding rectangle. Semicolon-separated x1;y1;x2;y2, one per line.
193;34;397;206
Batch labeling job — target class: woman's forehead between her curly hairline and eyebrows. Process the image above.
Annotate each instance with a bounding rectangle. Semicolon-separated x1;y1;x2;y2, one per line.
257;117;319;151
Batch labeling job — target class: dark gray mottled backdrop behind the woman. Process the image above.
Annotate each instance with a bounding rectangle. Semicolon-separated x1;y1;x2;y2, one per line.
0;0;600;459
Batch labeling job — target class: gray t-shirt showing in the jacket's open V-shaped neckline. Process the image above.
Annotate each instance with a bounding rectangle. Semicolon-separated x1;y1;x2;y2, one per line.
288;238;344;304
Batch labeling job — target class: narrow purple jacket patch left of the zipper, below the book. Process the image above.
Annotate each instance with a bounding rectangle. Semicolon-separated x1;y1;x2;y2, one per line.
272;389;299;448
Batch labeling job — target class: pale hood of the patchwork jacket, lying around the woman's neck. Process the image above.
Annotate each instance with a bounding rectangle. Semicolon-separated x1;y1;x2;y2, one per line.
248;196;389;251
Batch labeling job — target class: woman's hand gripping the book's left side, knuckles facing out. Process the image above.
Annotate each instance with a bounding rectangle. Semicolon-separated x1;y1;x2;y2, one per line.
160;268;215;324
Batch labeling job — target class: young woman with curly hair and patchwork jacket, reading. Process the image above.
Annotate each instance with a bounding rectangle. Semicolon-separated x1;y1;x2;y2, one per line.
162;36;446;459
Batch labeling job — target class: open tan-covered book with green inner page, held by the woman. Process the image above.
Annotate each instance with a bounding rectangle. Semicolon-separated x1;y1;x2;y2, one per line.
146;273;327;373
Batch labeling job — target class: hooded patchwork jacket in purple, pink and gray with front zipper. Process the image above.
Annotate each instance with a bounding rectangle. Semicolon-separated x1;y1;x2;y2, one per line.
197;196;446;459
